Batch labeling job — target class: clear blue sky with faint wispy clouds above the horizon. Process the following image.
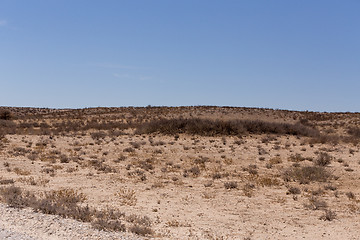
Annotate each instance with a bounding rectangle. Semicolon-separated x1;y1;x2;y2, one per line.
0;0;360;112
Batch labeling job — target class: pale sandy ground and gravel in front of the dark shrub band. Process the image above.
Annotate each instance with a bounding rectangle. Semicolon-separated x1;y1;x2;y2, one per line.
0;108;360;239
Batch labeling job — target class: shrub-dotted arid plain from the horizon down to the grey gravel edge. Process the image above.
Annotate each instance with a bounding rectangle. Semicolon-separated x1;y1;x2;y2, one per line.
0;106;360;239
